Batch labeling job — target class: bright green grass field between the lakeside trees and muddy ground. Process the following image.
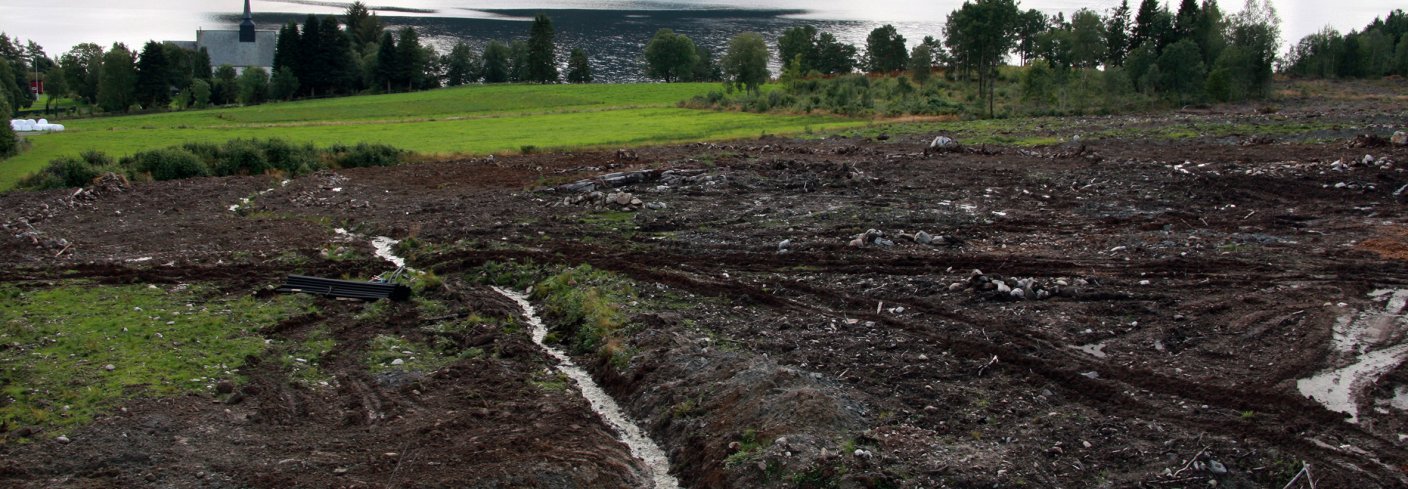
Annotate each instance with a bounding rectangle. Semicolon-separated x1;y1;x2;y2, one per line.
0;83;866;190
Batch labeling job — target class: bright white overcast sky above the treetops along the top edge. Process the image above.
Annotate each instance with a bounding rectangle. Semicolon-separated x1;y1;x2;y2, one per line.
0;0;1408;55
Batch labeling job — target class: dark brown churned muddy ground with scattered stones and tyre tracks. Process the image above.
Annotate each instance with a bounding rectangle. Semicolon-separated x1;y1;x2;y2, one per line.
0;94;1408;488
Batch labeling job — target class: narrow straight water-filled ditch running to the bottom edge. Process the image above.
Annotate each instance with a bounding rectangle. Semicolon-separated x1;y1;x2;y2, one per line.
492;287;680;489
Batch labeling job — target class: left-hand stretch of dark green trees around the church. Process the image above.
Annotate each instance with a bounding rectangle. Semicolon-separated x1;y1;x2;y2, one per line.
0;1;594;114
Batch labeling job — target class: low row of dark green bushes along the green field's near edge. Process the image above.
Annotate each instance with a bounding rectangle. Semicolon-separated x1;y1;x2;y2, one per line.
20;140;407;190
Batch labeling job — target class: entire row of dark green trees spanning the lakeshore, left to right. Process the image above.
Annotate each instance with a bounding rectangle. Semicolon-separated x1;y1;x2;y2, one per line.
8;0;1408;124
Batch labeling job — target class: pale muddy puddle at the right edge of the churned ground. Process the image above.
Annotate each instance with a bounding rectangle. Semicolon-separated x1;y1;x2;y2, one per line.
1295;290;1408;423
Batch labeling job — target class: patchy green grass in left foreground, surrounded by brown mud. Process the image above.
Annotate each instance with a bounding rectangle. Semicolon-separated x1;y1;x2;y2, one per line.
0;282;311;442
